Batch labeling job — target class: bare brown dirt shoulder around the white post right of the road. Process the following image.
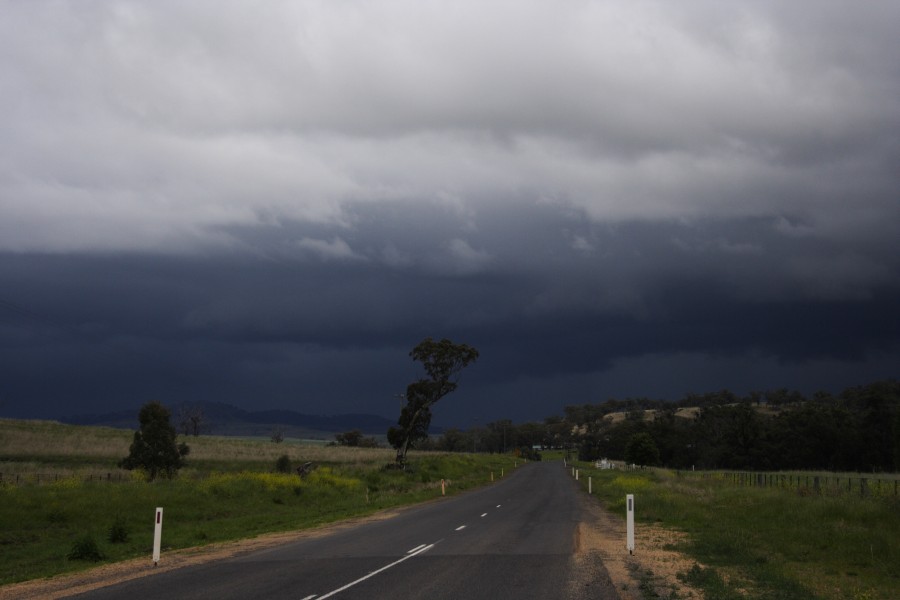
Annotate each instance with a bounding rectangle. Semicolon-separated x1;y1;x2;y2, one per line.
576;499;703;600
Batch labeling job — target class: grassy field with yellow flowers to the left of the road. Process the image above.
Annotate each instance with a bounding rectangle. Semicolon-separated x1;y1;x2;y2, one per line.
0;420;516;585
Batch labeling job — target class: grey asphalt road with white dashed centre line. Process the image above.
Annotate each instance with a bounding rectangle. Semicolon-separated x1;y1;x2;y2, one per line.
75;462;617;600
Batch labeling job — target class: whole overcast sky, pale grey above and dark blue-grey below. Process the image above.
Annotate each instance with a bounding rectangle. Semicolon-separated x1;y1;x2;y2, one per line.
0;0;900;427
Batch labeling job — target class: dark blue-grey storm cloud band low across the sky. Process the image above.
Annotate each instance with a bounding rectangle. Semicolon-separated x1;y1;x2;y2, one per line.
0;205;900;422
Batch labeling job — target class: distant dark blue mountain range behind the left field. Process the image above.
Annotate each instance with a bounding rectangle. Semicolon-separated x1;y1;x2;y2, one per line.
60;402;396;439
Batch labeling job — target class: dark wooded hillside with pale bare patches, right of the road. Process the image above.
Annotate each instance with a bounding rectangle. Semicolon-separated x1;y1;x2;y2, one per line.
417;380;900;472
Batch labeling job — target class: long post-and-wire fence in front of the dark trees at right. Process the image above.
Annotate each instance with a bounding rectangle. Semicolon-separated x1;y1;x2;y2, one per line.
701;471;900;498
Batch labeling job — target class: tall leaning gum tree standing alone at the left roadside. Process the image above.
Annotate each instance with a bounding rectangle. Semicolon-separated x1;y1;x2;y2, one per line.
388;337;478;469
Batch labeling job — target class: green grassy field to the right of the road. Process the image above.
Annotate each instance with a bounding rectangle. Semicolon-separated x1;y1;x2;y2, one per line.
573;463;900;600
